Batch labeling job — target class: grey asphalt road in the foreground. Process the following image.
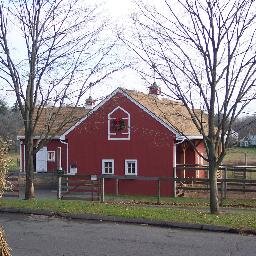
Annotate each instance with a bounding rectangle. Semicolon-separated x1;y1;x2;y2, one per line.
0;214;256;256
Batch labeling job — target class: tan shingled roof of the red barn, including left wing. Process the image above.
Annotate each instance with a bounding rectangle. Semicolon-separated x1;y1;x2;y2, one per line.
19;88;207;140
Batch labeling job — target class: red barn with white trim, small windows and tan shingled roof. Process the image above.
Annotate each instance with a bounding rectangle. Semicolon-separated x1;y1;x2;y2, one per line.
20;88;207;195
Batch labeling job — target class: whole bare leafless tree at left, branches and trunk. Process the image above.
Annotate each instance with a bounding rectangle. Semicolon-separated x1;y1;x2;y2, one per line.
0;0;124;199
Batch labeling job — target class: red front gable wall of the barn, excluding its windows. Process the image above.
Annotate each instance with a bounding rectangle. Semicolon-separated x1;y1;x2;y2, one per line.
67;94;174;195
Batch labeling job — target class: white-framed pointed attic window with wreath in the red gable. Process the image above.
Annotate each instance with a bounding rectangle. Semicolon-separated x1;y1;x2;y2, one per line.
108;107;130;140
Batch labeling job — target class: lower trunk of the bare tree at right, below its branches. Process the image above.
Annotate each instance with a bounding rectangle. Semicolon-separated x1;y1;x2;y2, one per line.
209;161;219;214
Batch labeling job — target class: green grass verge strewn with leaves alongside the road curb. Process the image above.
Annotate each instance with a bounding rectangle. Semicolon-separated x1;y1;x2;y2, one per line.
0;199;256;229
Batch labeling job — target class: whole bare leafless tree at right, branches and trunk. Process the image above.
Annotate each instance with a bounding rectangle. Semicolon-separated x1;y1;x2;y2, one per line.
123;0;256;213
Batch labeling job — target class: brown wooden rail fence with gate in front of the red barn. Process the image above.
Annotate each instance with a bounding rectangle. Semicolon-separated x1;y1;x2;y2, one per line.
58;165;256;202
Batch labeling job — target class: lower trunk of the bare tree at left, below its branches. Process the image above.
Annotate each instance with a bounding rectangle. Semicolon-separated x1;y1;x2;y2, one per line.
25;135;35;200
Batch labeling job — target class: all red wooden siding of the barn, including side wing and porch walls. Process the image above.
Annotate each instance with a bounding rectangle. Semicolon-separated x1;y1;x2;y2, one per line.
18;90;205;196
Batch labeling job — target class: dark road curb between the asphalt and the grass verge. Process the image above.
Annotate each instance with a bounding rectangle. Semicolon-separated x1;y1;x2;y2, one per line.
0;207;256;235
